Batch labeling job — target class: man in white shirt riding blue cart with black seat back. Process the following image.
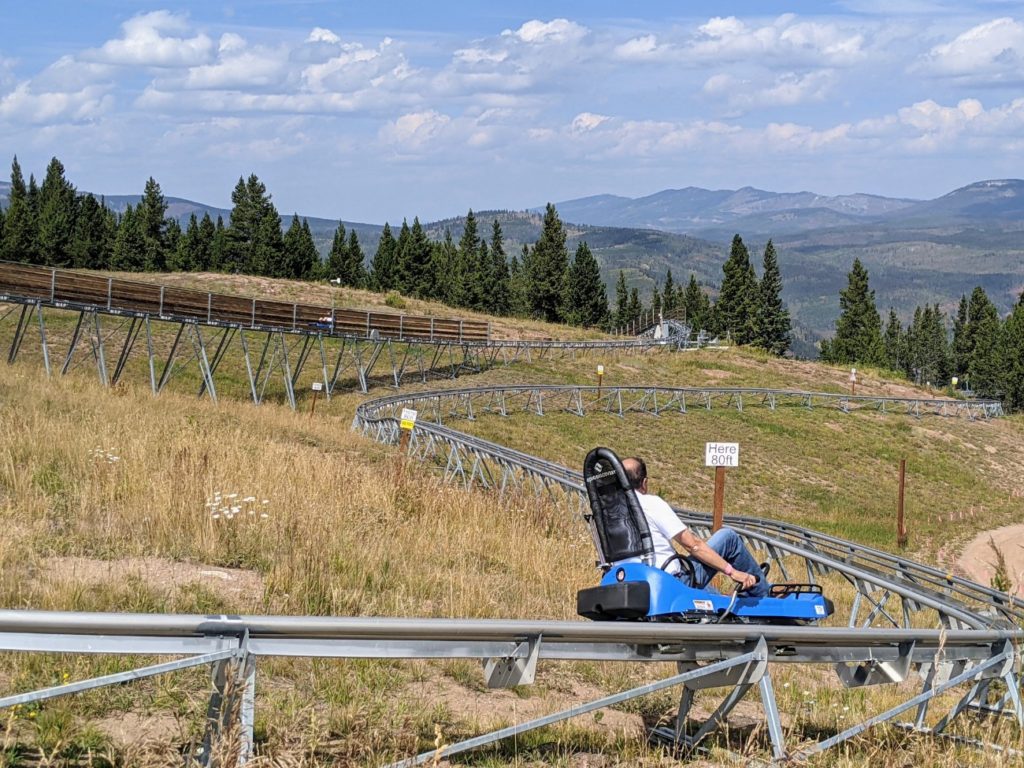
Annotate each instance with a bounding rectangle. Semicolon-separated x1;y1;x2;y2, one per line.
577;447;833;624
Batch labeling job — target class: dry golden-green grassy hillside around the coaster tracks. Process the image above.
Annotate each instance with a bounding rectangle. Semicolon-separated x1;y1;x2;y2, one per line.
0;276;1024;768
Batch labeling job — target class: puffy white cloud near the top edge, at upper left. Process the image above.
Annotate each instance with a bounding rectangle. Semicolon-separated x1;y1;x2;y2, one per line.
82;10;213;67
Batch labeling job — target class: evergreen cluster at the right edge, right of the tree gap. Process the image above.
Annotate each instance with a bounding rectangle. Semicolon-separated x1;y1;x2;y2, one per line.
821;259;1024;409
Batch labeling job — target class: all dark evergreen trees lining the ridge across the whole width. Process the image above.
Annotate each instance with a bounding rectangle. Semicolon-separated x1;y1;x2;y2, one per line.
0;157;1024;408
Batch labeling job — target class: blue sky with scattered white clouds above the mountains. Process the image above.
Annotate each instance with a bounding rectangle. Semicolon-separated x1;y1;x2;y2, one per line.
0;0;1024;222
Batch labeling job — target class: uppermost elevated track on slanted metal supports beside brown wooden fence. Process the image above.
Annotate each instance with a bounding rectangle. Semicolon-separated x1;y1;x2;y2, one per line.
0;274;702;409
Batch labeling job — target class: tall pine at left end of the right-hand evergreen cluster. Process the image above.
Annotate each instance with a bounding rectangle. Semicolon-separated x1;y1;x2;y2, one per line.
822;259;885;366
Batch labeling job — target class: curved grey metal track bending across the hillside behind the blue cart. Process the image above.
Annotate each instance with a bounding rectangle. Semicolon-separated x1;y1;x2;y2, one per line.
352;385;1024;639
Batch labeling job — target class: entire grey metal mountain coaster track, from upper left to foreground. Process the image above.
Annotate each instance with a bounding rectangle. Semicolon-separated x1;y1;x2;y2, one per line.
0;262;1024;765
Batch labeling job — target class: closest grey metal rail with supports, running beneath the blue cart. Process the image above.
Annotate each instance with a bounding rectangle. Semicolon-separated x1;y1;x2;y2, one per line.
0;610;1024;766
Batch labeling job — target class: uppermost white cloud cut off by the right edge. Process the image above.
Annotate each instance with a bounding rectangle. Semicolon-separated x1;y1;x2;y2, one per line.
924;18;1024;80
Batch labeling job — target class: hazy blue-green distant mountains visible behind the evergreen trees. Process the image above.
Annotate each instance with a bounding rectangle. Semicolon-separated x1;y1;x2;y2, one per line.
0;179;1024;355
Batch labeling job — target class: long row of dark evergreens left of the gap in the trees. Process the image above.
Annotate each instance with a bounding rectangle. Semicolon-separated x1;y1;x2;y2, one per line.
0;157;790;354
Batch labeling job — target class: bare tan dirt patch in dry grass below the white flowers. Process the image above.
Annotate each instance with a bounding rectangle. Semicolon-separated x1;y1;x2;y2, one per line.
39;557;263;600
